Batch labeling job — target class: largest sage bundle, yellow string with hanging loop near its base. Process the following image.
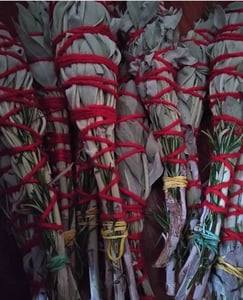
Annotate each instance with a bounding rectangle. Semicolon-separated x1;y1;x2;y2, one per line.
53;2;131;299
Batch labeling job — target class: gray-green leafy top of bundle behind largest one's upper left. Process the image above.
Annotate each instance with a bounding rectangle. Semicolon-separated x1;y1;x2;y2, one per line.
15;1;57;87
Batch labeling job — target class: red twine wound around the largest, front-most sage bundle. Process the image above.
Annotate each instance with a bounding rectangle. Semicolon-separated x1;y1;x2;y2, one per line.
53;25;125;225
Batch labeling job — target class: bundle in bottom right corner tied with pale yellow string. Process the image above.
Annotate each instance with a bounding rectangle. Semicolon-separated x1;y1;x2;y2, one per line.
209;148;243;299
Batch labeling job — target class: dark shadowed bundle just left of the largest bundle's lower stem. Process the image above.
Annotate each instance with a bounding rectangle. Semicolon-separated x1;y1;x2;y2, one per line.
75;145;100;299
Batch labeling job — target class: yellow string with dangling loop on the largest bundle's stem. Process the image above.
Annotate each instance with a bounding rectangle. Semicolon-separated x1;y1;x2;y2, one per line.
101;221;128;261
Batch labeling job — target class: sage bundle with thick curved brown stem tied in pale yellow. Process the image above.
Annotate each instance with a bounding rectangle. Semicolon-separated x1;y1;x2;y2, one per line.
120;1;195;295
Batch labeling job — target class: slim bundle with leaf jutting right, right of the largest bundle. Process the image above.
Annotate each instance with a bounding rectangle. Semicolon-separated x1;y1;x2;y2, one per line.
115;78;162;299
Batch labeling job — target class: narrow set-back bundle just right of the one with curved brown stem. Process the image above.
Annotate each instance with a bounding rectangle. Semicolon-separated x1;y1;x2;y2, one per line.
176;13;214;211
